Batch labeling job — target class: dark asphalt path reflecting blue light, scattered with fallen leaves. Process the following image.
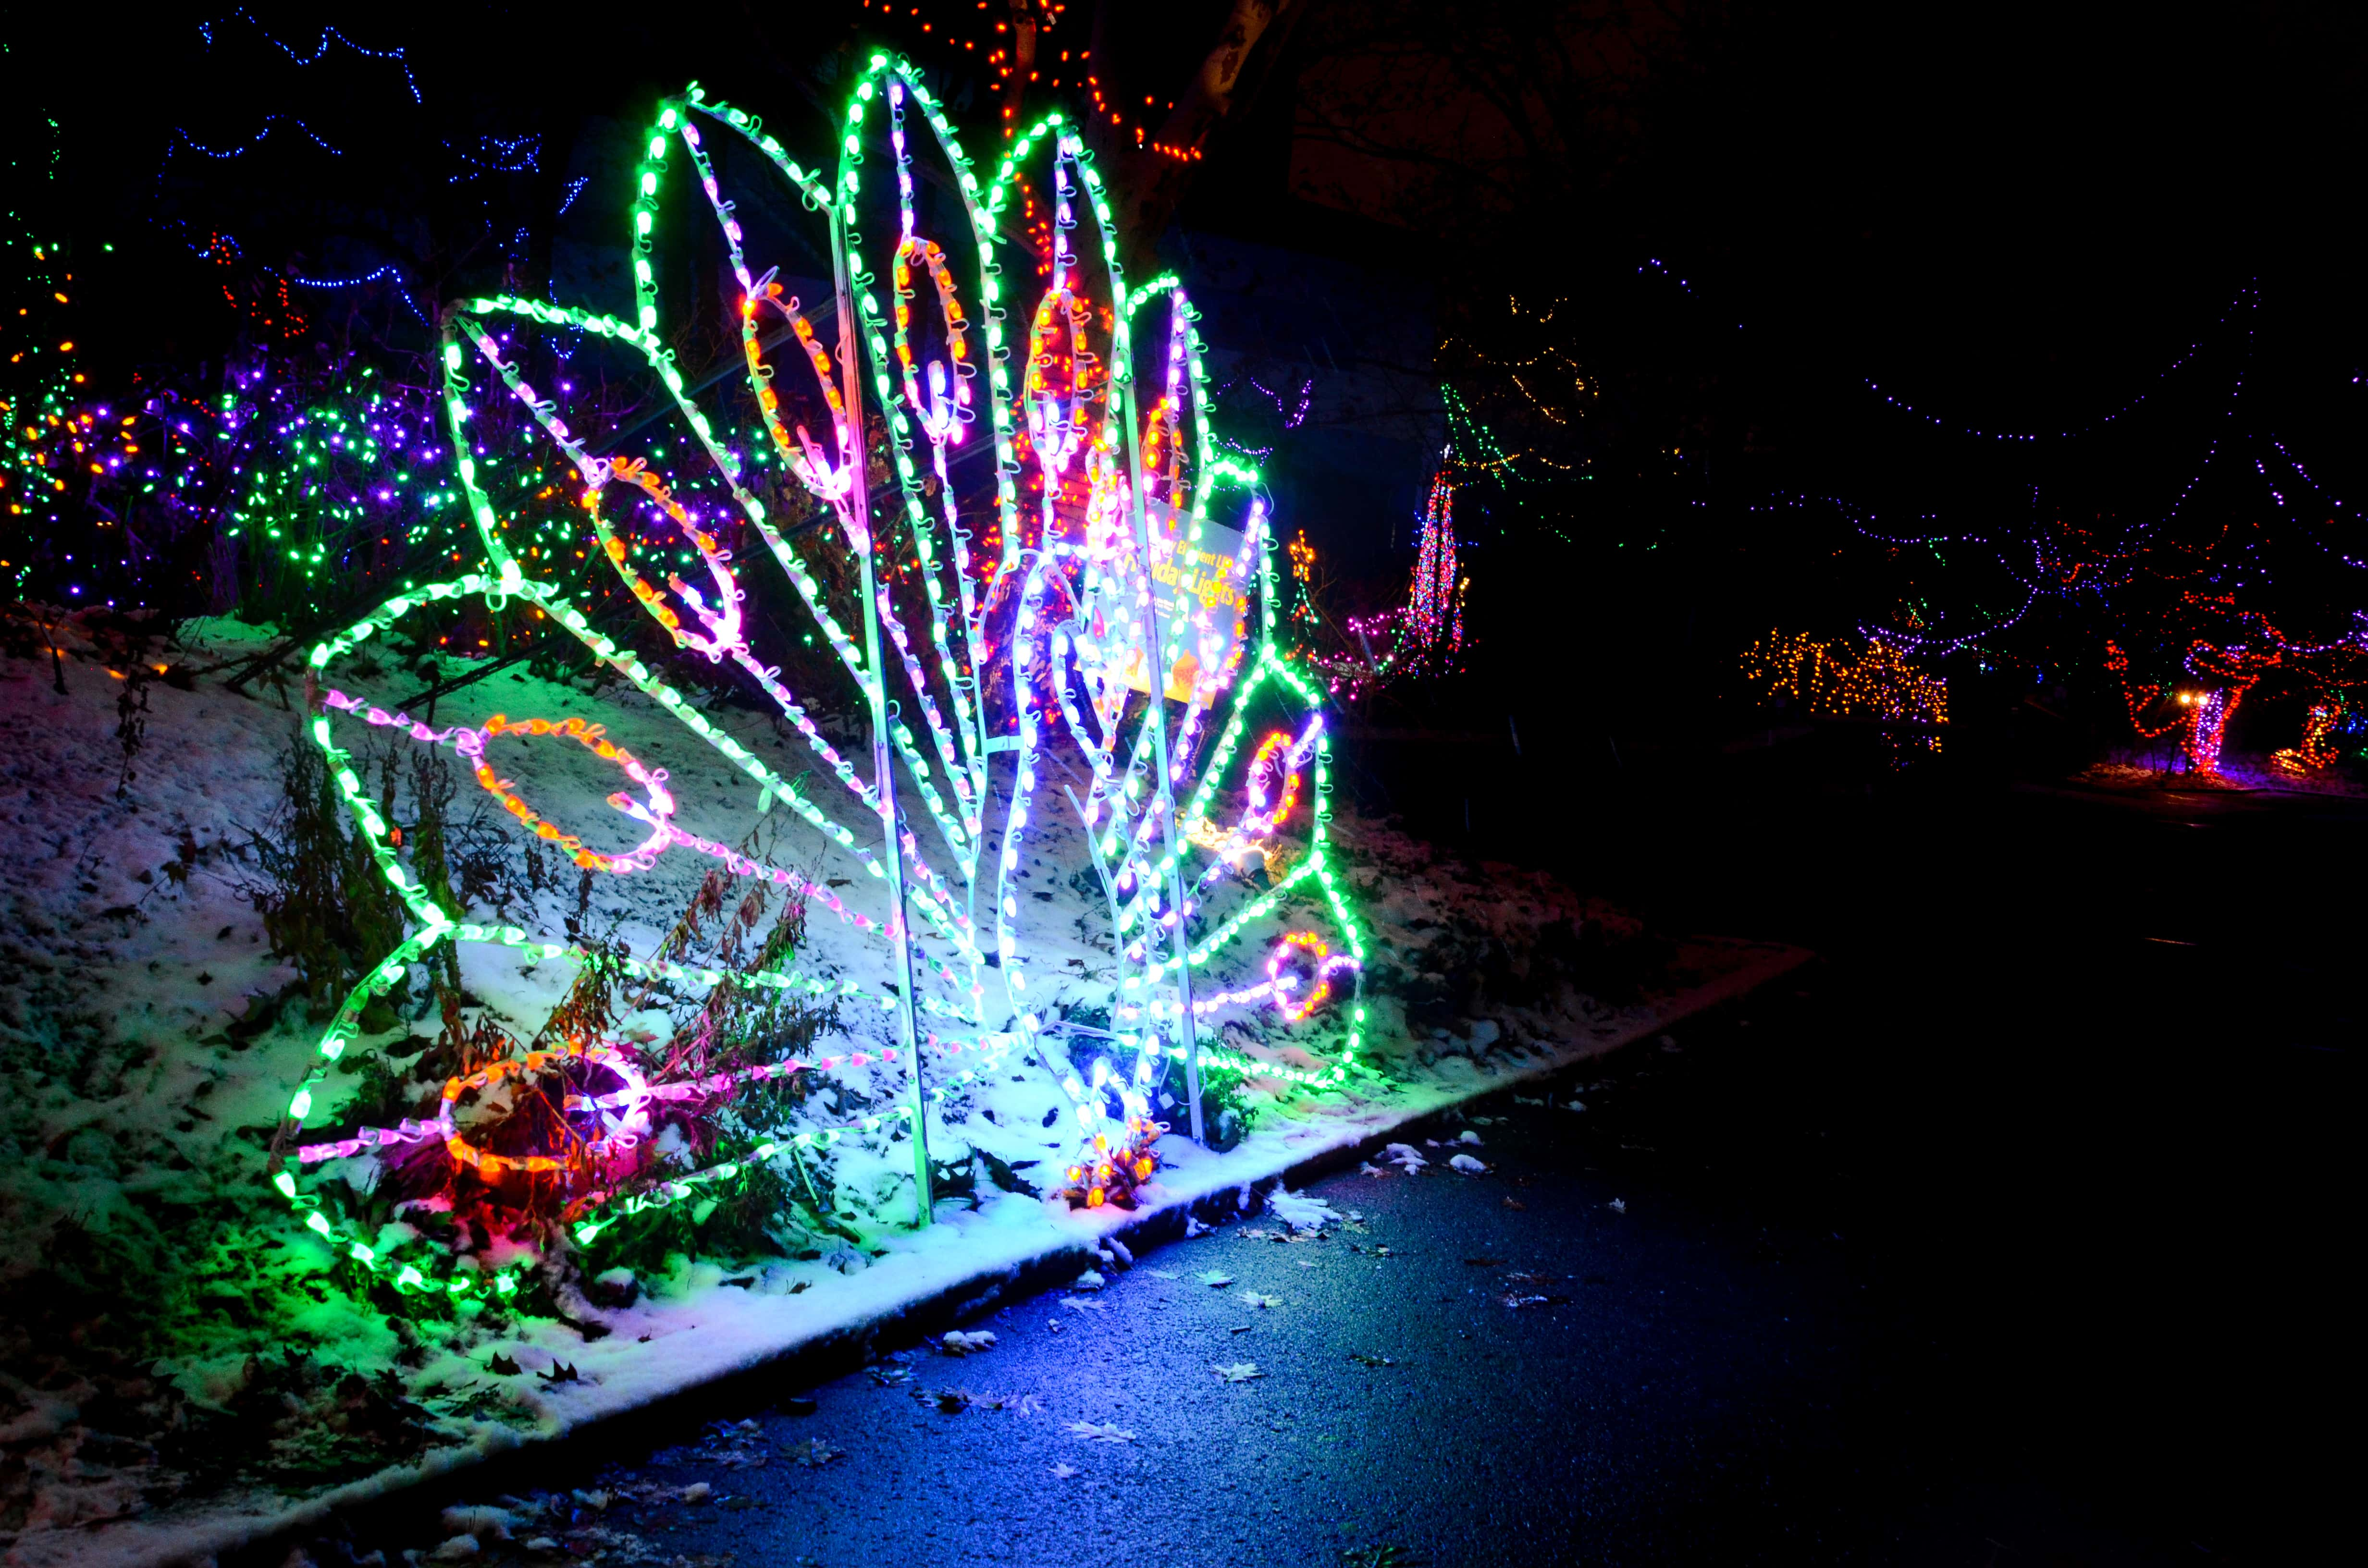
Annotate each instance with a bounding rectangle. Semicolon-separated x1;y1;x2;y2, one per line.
296;777;2368;1568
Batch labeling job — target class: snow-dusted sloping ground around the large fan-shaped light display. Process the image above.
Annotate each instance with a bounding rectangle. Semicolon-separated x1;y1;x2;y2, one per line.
0;623;1802;1563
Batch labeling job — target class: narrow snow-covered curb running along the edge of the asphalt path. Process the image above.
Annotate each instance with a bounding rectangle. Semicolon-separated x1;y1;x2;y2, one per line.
37;943;1814;1568
